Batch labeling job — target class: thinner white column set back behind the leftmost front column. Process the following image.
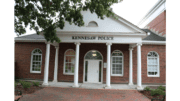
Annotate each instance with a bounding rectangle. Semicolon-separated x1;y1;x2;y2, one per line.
53;46;59;83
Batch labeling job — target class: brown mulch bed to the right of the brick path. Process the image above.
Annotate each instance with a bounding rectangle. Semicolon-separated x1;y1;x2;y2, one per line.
139;86;166;101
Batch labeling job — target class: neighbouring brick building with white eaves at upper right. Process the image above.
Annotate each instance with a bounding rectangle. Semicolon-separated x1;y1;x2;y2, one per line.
138;0;166;37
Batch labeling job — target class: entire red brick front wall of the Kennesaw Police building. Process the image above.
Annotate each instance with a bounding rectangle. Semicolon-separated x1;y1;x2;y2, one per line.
15;42;166;83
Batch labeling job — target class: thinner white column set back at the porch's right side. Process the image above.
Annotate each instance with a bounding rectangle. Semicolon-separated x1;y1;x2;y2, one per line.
129;47;133;85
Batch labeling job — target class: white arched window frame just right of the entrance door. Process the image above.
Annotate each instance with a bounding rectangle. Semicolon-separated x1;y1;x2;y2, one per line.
111;50;124;76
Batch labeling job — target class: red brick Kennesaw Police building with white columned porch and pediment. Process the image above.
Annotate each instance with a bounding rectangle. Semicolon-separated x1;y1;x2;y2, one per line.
15;8;166;89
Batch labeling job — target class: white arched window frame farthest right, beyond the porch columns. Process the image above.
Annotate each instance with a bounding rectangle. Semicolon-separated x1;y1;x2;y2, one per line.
147;51;160;77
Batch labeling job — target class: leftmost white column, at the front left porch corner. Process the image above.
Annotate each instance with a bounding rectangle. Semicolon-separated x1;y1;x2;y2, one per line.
43;42;50;85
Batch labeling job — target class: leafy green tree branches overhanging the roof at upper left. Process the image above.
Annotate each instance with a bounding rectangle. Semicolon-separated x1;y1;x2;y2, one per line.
14;0;121;42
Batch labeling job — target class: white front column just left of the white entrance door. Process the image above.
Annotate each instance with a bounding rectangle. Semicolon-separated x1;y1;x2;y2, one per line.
73;42;80;87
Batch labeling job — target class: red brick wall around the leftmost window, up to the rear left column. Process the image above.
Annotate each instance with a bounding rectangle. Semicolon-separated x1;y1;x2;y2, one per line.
15;42;54;80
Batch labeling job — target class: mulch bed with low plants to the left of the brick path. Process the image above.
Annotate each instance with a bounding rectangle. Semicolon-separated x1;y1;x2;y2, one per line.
15;81;44;95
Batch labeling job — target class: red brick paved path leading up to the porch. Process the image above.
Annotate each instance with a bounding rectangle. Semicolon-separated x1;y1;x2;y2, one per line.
20;87;150;101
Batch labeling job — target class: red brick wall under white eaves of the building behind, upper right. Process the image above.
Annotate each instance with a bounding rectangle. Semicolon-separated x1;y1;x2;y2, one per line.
147;11;166;35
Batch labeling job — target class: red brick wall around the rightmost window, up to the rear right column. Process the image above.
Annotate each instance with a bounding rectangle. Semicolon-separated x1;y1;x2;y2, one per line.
133;45;166;84
